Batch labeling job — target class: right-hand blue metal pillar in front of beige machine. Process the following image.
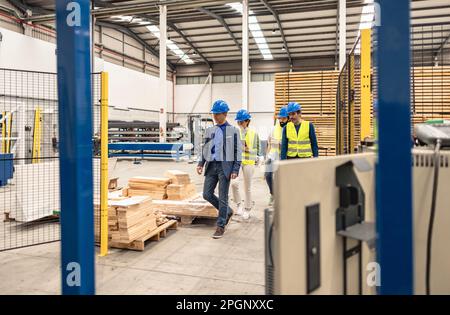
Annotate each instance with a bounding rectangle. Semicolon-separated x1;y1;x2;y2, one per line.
376;0;414;294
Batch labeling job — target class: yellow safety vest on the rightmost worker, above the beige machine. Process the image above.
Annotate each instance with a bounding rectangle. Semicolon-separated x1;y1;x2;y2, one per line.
286;121;312;158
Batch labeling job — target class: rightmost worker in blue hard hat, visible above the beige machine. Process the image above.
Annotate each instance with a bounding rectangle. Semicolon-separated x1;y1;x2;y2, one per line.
281;102;319;160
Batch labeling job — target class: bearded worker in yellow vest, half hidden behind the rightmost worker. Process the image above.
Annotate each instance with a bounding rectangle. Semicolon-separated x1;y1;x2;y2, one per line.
264;107;289;205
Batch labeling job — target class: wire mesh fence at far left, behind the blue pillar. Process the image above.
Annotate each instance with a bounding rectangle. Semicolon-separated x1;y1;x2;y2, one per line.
0;69;101;251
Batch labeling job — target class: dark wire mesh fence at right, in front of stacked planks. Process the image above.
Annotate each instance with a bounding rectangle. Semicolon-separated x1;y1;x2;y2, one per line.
336;21;450;154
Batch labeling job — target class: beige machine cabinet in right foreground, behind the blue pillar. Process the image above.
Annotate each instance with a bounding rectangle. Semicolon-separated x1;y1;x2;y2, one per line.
266;148;450;294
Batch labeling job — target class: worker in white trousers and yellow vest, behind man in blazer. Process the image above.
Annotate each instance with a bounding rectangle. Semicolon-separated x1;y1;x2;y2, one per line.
231;109;260;220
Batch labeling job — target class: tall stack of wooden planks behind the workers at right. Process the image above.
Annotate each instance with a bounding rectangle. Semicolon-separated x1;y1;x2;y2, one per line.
275;66;450;156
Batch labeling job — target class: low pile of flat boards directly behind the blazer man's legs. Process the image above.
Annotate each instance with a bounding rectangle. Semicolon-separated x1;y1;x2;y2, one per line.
153;194;219;224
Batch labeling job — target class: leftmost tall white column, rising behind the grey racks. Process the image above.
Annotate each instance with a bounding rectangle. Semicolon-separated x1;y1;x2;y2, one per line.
159;5;168;143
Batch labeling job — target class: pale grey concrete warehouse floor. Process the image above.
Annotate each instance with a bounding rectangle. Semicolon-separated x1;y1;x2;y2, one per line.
0;161;269;295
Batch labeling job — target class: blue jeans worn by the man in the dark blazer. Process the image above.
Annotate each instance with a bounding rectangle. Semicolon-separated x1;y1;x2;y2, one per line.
203;162;232;228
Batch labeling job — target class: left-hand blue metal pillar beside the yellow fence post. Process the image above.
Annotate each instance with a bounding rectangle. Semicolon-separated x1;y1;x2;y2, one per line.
55;0;95;294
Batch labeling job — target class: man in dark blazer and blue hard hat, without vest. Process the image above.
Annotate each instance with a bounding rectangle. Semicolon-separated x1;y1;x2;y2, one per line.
197;100;242;239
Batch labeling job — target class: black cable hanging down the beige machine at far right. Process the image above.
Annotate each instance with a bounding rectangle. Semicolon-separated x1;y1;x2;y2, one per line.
425;139;441;295
